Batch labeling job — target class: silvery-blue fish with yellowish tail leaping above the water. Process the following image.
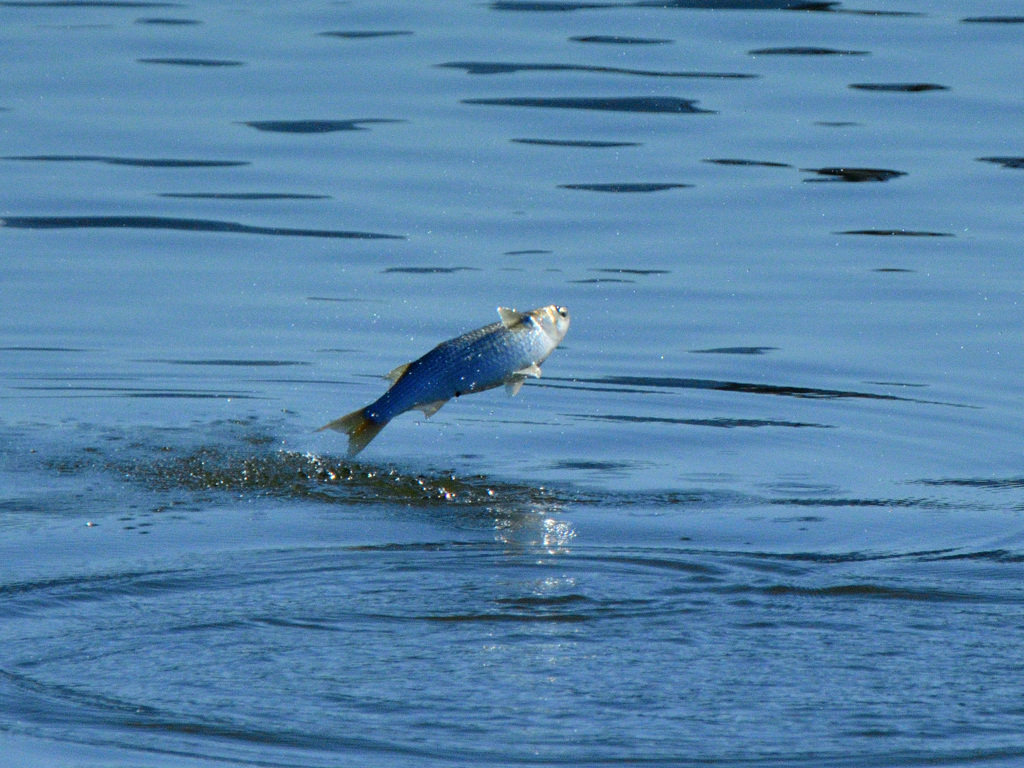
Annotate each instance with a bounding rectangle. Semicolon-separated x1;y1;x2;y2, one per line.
316;304;569;458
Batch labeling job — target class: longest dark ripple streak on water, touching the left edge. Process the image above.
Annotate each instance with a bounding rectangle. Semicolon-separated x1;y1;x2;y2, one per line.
0;216;406;240
